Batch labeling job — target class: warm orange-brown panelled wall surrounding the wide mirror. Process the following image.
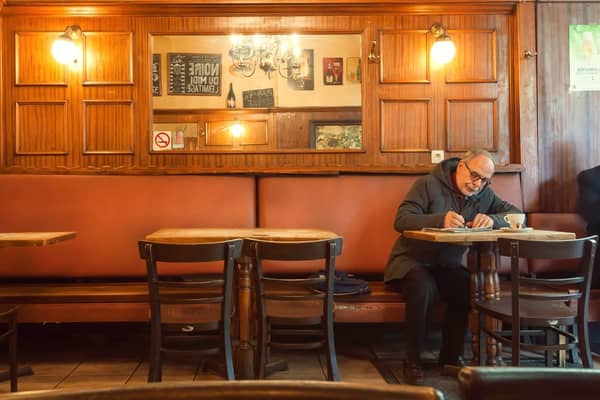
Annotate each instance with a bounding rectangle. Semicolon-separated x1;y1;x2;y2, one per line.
0;0;537;209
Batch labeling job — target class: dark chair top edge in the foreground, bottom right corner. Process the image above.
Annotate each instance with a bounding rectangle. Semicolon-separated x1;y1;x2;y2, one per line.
458;367;600;400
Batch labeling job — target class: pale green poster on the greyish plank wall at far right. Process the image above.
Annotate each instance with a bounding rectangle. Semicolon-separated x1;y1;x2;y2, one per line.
569;25;600;91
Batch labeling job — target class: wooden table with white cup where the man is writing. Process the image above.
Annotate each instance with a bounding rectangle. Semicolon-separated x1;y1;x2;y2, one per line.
402;229;575;365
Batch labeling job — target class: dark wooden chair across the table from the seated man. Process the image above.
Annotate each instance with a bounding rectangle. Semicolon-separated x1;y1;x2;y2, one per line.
474;236;598;368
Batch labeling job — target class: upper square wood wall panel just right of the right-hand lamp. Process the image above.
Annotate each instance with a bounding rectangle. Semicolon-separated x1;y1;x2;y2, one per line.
446;29;498;83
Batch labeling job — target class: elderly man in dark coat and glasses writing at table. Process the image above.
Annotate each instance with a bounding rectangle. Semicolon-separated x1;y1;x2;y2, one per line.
384;149;521;384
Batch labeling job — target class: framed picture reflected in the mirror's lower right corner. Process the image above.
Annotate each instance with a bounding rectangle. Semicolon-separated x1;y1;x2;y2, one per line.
310;121;362;150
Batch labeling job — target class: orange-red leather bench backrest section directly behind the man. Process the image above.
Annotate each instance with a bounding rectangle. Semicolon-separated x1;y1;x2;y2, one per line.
258;173;523;275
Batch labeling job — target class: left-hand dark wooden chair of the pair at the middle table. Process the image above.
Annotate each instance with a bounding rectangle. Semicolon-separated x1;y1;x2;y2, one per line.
138;239;243;382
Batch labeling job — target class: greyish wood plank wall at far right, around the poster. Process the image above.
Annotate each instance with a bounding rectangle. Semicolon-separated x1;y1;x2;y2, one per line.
537;2;600;212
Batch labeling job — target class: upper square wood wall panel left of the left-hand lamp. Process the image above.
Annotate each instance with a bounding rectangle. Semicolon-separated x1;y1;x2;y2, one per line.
15;32;67;86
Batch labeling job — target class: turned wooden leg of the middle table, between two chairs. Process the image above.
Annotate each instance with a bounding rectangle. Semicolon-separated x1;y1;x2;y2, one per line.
235;256;254;379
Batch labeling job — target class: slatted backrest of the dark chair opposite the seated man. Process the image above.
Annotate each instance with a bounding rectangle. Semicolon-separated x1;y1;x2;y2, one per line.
498;236;598;322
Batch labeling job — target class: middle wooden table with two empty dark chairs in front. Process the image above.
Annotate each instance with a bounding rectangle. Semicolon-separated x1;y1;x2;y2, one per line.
146;228;339;379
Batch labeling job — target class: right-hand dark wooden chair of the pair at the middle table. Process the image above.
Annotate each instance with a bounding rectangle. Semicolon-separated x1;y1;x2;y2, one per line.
248;238;342;381
